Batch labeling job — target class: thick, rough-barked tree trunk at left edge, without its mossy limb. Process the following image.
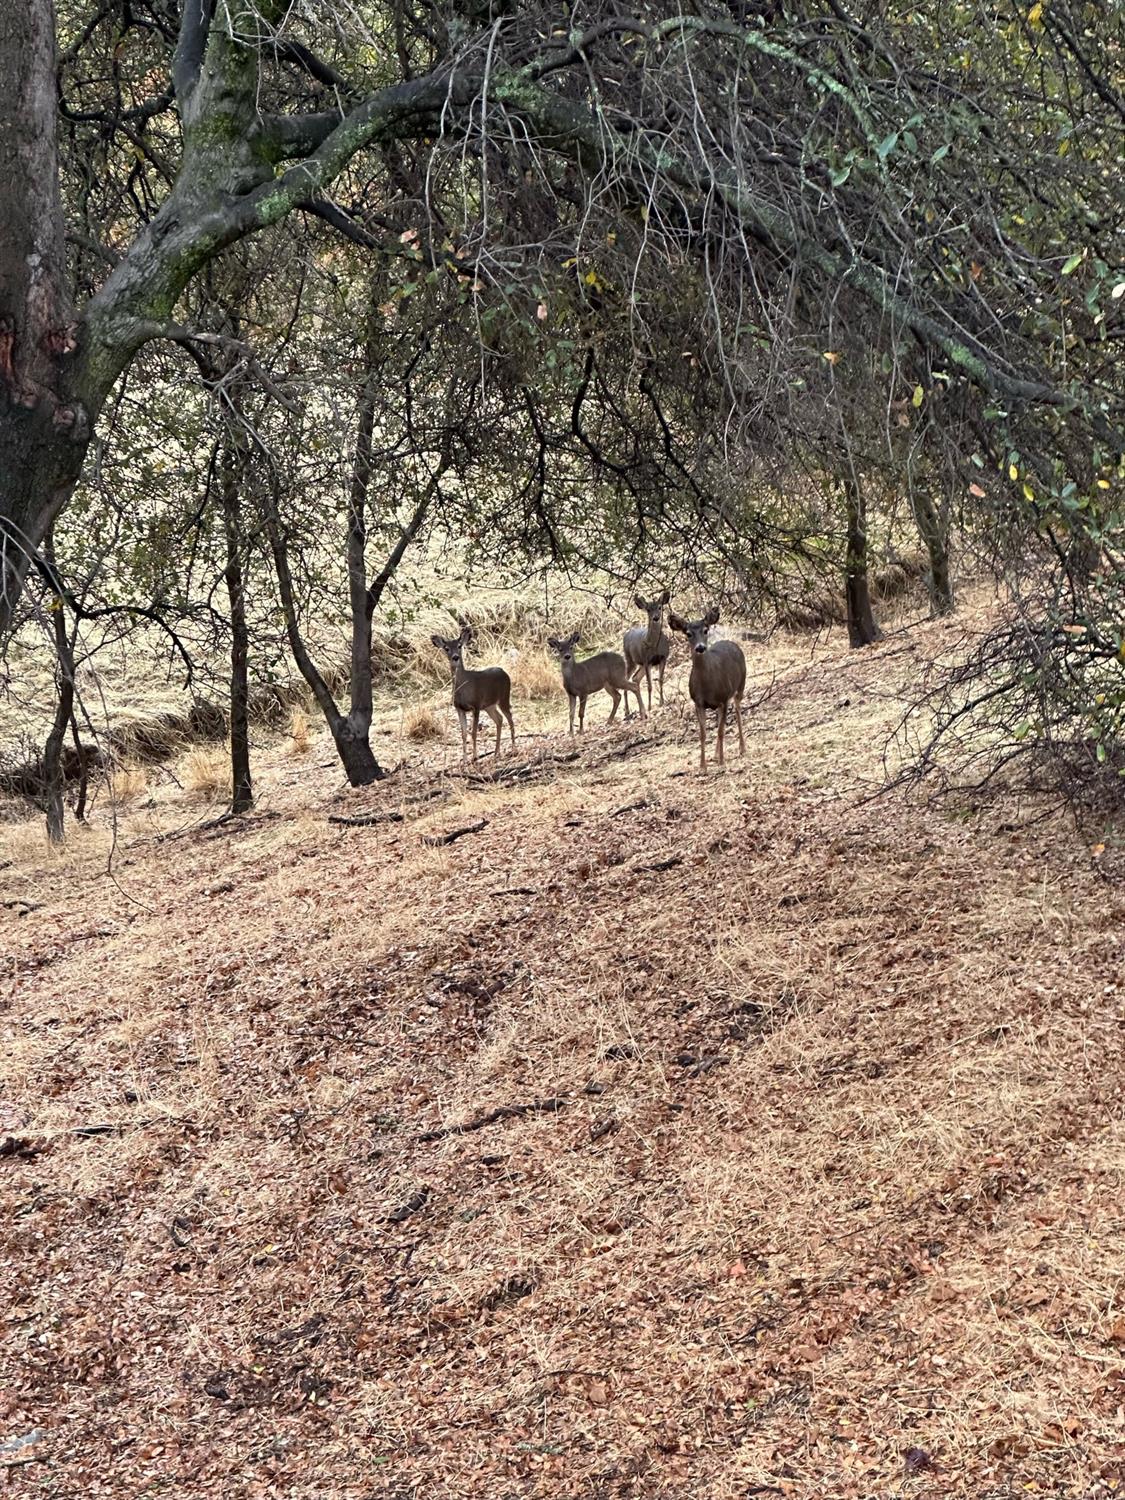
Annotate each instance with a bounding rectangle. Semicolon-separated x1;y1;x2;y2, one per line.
0;0;96;636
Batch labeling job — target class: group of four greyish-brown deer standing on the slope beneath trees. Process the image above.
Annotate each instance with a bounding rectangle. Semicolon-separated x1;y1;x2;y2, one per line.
432;590;746;771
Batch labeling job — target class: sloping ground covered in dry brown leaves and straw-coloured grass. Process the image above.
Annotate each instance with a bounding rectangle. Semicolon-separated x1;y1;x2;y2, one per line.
0;603;1125;1500
